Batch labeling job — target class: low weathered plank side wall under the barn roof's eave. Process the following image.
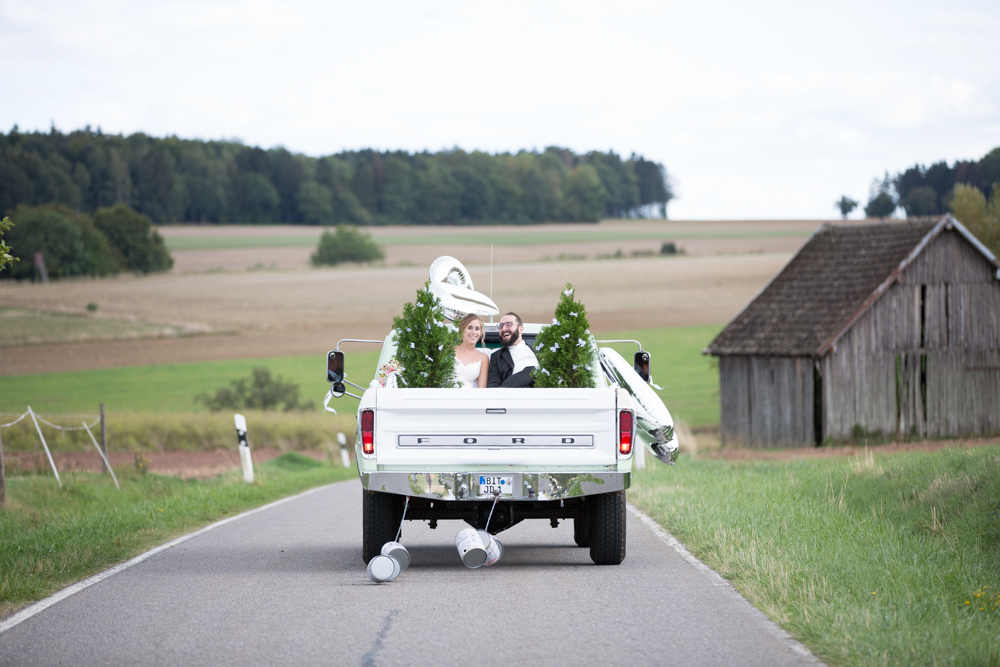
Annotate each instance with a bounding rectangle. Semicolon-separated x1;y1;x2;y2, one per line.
719;355;815;447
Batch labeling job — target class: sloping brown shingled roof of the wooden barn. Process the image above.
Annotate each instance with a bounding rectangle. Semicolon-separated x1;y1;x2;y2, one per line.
705;215;1000;356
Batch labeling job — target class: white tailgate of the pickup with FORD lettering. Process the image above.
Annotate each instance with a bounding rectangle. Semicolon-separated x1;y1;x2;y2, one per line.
375;388;617;471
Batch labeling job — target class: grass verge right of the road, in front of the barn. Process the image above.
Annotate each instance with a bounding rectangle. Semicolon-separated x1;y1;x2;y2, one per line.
630;445;1000;665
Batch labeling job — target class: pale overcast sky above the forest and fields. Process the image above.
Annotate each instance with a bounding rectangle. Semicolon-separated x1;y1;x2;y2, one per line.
0;0;1000;220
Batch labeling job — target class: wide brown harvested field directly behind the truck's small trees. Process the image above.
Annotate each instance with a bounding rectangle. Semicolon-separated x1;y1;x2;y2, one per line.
0;251;790;375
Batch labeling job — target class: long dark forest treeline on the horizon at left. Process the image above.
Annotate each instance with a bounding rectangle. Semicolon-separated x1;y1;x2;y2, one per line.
0;126;673;225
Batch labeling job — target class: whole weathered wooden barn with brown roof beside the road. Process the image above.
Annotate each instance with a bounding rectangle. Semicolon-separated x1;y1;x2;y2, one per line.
705;215;1000;447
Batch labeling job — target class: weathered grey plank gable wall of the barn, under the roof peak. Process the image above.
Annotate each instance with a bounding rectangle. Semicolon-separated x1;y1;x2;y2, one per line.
820;231;1000;439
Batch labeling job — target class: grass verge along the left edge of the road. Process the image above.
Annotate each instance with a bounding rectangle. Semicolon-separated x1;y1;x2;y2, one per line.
0;453;357;617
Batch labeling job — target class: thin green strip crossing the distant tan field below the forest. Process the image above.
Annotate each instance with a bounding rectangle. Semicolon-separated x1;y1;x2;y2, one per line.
165;227;811;250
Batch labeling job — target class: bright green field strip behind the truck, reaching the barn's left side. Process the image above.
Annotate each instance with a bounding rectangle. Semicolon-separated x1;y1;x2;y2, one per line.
0;325;721;426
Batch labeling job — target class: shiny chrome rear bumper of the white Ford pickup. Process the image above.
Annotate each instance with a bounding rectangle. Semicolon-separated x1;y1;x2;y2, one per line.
361;472;632;501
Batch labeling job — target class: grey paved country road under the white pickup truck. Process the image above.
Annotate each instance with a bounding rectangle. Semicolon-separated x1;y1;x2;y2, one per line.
0;482;814;667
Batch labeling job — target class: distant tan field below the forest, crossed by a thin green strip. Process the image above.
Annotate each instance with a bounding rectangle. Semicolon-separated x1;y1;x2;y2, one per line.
160;220;819;273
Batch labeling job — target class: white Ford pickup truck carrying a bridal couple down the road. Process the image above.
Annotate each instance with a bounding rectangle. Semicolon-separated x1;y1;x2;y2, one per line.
327;323;678;565
